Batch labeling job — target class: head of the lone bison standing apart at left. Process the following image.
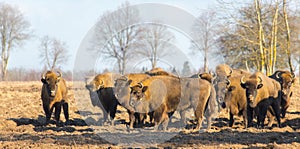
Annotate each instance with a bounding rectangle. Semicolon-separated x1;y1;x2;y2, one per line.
41;71;62;97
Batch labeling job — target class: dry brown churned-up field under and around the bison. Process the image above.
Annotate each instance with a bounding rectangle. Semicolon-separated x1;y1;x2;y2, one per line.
0;82;300;149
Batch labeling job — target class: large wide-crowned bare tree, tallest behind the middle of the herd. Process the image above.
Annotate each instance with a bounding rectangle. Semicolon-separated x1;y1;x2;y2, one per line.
92;2;142;74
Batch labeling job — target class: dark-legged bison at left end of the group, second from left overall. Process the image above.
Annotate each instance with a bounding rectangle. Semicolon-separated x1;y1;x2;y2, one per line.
86;72;121;125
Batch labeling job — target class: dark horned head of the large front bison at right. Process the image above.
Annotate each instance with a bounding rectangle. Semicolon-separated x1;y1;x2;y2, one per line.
240;76;263;108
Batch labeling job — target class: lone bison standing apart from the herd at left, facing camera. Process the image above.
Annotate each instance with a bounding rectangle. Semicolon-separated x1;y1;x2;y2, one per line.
41;71;69;125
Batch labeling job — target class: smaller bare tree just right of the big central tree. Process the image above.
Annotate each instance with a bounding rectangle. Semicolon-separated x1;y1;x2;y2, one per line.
137;22;175;68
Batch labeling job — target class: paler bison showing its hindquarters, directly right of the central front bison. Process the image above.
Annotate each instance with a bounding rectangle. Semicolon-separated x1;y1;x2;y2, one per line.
177;78;218;130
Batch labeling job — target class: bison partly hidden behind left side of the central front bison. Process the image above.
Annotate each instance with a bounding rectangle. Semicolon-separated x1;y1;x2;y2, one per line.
114;73;150;129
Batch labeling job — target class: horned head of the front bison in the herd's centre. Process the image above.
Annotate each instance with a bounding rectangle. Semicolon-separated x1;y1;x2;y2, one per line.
130;83;148;106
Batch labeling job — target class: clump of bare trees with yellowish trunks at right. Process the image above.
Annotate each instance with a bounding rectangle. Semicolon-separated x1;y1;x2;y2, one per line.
219;0;298;75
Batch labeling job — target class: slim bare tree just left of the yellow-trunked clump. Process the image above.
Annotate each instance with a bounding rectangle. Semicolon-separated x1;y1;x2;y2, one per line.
192;10;218;72
